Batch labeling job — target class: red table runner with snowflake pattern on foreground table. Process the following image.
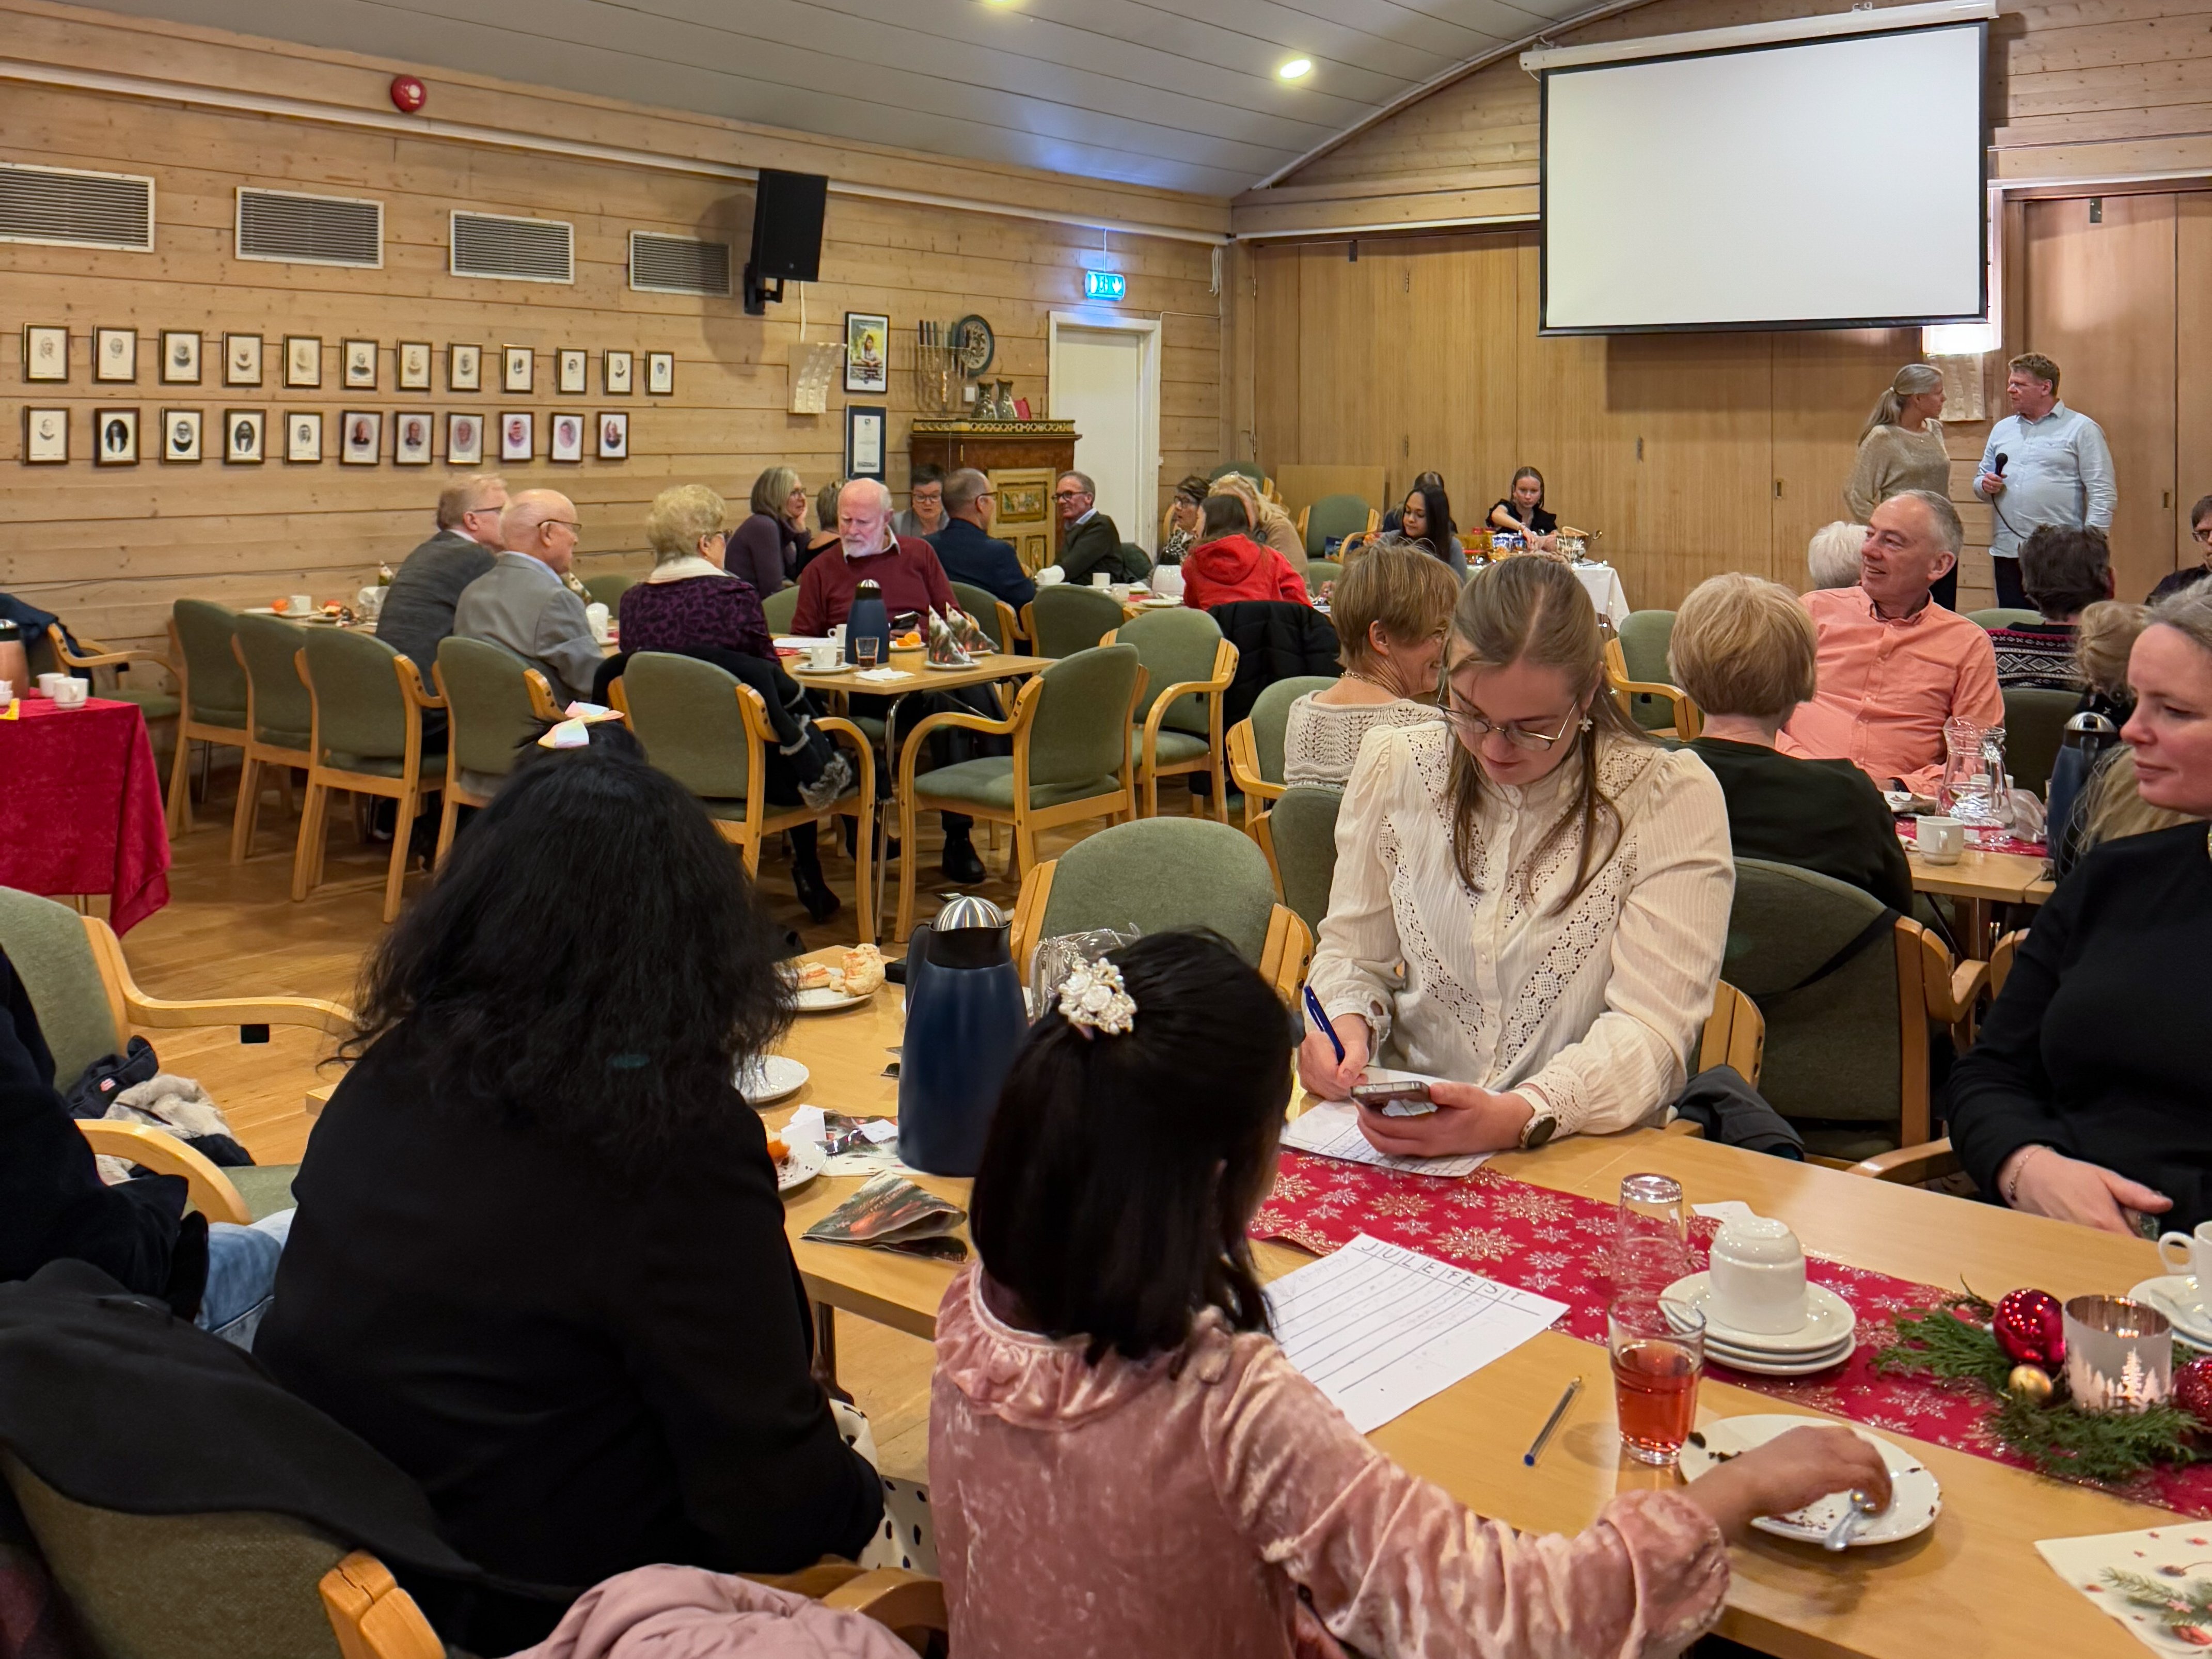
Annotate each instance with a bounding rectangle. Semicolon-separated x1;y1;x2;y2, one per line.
1252;1152;2212;1518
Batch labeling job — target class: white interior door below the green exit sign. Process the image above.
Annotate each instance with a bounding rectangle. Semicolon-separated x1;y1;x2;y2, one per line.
1051;314;1159;553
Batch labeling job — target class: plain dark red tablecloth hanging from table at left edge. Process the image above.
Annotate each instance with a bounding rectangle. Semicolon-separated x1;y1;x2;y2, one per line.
0;697;168;934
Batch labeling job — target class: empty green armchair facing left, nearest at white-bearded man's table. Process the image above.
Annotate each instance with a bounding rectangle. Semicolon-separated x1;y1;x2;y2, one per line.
896;645;1146;938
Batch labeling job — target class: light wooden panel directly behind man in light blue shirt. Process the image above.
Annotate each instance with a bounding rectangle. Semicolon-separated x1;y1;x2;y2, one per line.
2026;195;2186;597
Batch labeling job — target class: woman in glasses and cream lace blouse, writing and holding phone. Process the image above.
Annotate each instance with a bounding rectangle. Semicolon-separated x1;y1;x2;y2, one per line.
1299;560;1734;1157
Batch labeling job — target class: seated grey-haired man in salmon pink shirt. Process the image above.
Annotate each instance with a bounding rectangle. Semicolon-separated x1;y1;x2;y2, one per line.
1776;489;2004;796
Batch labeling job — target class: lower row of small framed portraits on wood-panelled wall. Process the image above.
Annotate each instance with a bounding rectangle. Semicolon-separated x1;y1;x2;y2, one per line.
22;409;630;467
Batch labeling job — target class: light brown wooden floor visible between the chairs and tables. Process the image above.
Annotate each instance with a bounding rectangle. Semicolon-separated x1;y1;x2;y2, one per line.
124;772;1183;1480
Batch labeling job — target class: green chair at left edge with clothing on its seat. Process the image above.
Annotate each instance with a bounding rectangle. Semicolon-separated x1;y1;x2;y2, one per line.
0;887;354;1221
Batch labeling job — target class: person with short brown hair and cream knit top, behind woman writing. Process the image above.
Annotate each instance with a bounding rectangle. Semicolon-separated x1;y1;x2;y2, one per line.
1283;546;1460;789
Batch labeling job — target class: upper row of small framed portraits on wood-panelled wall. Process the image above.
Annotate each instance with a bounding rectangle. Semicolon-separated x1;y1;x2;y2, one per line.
22;323;677;398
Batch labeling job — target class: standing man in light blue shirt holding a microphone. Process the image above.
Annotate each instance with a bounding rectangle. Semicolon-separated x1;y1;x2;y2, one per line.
1973;352;2119;610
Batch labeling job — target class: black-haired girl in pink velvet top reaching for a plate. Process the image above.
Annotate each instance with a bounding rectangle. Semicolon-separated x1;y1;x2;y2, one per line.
929;934;1889;1659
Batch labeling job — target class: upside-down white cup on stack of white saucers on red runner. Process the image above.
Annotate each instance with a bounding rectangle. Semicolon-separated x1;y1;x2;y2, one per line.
1661;1216;1858;1376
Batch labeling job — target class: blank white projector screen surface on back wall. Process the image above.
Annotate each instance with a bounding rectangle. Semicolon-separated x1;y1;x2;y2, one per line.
1544;22;1984;334
